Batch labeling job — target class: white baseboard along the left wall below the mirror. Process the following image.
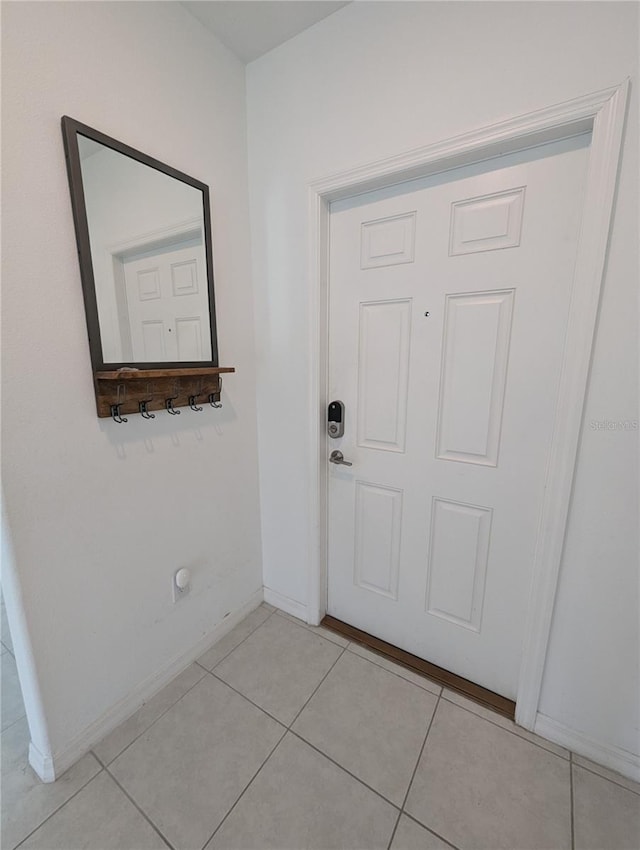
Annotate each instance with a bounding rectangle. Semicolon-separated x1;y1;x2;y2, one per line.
38;588;264;782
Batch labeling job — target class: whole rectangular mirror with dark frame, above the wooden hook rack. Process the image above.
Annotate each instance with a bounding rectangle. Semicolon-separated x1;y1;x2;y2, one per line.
62;116;218;371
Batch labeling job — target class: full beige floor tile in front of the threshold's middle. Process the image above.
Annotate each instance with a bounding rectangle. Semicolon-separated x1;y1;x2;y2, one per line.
292;652;438;806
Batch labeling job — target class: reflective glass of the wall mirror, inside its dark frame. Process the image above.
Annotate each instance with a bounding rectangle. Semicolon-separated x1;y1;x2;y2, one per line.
78;134;212;363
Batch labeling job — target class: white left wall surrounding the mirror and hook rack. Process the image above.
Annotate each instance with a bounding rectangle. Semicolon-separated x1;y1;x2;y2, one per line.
2;2;262;754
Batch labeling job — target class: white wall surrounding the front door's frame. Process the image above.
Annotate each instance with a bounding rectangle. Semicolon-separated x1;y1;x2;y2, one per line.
247;2;639;753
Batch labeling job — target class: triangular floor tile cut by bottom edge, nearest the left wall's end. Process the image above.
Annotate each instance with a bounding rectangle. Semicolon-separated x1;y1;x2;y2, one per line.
20;771;167;850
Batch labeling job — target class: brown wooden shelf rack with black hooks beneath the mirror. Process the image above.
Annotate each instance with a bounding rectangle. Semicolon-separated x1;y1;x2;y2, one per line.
94;366;235;422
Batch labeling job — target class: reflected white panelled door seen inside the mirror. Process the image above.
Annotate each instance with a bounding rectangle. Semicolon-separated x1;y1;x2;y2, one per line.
114;232;211;362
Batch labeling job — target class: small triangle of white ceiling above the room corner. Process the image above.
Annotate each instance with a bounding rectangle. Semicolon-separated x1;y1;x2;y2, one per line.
182;0;347;62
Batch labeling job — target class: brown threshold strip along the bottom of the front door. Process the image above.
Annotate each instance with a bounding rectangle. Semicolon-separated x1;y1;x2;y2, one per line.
321;614;516;720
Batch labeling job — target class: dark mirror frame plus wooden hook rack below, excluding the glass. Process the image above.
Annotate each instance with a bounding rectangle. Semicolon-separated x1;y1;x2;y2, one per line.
62;115;235;423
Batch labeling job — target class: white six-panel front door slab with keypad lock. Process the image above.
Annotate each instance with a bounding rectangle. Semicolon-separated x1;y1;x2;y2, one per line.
328;136;589;699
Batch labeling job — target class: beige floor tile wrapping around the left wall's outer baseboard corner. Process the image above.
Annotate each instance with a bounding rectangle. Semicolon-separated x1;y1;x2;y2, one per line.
1;718;100;850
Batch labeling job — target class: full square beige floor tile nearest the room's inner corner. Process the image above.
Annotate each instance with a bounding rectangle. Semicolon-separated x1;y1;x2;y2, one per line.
215;615;343;726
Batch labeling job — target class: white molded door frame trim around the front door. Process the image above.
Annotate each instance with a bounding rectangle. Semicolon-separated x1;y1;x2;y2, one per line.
307;79;629;729
